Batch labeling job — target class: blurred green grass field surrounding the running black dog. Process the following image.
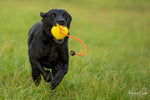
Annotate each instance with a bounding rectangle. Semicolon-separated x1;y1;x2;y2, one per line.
0;0;150;100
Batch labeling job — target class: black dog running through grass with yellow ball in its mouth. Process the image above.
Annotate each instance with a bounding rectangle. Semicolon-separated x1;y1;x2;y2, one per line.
28;9;72;90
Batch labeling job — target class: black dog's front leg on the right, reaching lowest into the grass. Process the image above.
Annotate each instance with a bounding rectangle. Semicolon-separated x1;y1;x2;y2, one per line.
51;64;68;90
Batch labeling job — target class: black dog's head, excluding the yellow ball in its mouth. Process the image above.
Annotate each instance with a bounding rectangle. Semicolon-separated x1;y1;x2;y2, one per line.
40;9;72;43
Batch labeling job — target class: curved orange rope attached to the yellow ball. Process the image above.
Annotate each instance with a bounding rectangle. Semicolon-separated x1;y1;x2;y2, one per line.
59;28;86;56
